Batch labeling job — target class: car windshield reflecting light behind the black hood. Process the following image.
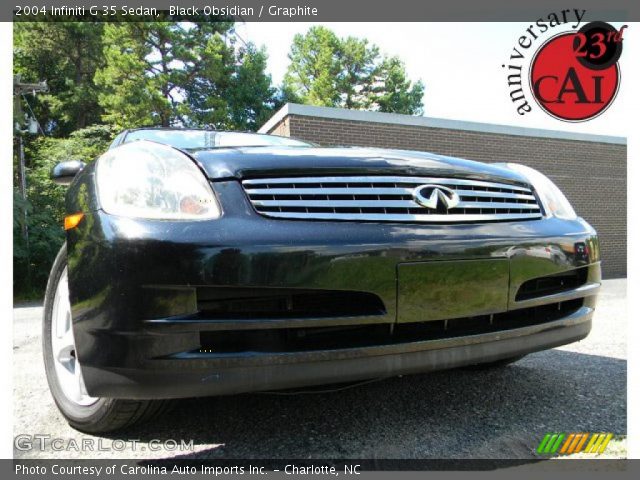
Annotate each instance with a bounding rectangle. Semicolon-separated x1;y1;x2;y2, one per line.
123;129;311;149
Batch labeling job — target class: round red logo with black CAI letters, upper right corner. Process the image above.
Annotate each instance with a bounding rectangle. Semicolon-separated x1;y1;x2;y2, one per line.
529;29;621;122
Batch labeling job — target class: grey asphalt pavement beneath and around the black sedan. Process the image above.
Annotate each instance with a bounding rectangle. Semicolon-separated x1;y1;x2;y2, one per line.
13;279;627;459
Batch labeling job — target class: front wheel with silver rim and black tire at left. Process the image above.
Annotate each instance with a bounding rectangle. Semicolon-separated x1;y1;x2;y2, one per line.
42;244;170;433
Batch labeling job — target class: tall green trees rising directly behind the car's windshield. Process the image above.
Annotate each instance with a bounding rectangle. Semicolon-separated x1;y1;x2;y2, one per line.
95;22;275;129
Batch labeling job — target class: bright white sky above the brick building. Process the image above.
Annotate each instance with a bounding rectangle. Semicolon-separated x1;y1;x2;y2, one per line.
236;23;634;136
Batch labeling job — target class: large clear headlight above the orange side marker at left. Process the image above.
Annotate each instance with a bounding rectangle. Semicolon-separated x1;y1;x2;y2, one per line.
96;140;220;220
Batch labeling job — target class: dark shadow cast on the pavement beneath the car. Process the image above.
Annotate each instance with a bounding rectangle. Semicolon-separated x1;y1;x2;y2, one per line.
106;350;627;459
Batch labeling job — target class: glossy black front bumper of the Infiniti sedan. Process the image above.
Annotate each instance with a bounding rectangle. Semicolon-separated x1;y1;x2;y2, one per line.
68;181;600;398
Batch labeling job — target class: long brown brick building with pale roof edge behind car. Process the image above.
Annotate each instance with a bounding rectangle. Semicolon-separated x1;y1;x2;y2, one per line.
260;104;627;278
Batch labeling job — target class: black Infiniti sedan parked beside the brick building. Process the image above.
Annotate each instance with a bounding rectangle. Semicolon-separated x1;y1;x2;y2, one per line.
43;129;600;432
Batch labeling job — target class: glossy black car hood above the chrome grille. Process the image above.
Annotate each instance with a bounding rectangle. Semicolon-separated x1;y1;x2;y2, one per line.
187;147;527;184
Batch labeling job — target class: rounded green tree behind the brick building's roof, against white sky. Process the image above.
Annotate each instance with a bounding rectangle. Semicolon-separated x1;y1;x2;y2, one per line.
282;26;424;115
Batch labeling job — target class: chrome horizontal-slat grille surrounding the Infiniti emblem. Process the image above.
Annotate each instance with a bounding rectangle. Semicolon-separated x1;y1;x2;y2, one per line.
242;176;542;223
